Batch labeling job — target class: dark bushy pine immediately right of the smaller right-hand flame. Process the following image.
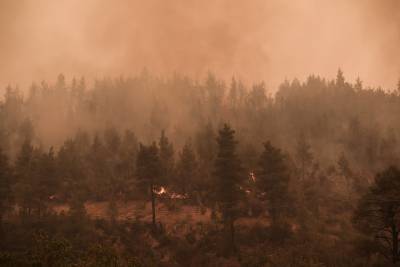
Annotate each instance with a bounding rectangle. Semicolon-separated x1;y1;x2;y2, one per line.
256;142;293;224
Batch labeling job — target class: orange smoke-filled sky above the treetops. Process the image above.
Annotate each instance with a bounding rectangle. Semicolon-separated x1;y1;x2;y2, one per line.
0;0;400;90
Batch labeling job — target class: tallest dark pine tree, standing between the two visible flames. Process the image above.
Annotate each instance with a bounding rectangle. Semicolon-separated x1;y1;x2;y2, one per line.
214;124;242;251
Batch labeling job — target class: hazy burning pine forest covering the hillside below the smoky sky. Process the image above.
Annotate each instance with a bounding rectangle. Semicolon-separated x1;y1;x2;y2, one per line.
0;69;400;267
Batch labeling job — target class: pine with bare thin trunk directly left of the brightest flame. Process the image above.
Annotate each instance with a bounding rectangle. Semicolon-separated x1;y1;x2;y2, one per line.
136;143;161;228
